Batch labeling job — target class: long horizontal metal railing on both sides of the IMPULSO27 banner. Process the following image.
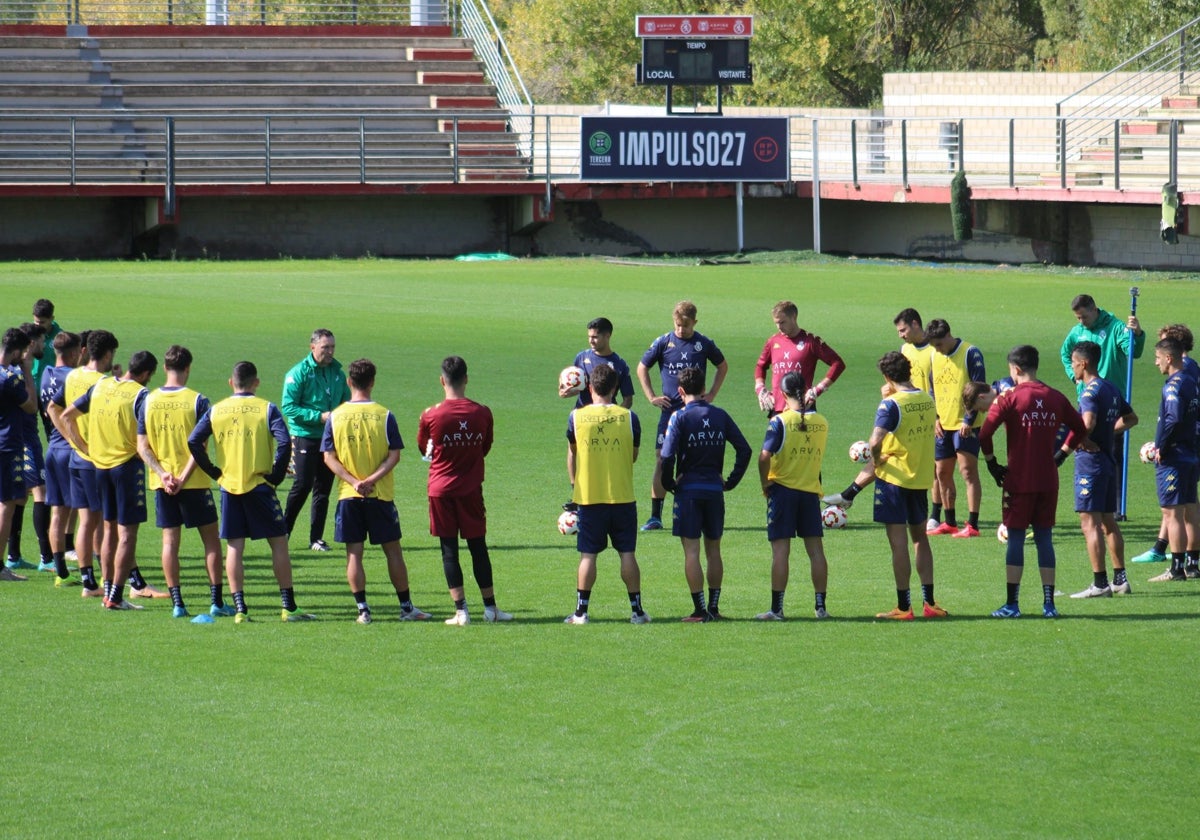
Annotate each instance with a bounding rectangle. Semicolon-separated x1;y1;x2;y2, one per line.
0;110;1200;191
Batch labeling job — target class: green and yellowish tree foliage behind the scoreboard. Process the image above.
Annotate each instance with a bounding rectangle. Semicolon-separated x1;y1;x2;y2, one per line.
492;0;1198;107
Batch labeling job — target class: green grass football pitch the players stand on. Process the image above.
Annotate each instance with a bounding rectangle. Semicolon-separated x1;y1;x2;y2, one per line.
0;257;1200;838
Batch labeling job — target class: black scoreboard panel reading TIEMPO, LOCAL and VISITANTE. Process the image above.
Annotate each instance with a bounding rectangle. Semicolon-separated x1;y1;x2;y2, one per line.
637;36;754;85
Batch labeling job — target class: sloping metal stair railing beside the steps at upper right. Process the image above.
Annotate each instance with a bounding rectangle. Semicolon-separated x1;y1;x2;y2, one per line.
1055;18;1200;186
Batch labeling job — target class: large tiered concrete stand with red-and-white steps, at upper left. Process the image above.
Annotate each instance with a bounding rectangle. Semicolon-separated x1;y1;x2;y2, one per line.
0;28;528;184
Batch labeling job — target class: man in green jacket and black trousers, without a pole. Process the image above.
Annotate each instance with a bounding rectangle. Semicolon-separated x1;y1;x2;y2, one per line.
280;330;350;551
